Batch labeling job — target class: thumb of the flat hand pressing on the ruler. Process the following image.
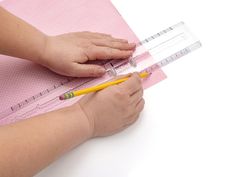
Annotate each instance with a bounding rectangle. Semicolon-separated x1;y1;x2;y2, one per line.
72;63;106;77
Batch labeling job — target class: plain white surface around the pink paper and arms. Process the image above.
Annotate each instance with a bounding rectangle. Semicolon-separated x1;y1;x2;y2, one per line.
37;0;236;177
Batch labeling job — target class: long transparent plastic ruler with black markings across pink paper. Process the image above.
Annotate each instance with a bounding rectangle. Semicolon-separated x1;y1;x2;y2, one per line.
0;22;201;125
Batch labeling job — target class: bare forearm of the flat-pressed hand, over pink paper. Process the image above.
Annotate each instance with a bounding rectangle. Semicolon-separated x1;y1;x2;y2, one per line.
0;7;46;63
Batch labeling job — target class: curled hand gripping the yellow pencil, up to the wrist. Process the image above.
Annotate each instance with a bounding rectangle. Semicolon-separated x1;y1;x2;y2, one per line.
77;73;144;137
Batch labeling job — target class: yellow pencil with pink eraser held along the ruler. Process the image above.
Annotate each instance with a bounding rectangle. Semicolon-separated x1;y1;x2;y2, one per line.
59;72;149;100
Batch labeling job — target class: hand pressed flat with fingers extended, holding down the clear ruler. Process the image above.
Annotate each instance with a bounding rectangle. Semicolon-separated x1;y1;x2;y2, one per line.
38;32;135;77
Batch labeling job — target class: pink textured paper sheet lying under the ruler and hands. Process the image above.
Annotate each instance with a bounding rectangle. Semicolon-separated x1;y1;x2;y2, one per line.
0;0;165;125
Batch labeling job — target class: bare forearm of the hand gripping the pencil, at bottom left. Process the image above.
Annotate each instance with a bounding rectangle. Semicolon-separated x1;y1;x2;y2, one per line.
0;106;91;177
